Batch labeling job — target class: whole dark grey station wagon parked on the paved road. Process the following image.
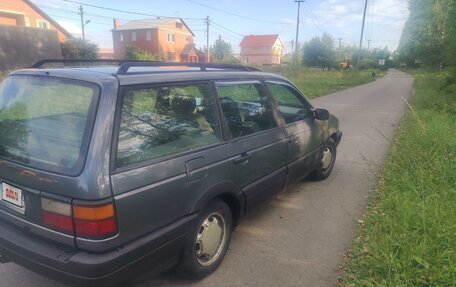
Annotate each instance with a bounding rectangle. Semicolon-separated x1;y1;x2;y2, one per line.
0;60;342;285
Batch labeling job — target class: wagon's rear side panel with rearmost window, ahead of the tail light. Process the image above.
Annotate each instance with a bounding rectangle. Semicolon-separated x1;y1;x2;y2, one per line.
111;82;227;244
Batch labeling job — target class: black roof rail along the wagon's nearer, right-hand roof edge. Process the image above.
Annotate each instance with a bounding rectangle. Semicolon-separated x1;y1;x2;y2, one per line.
116;60;260;75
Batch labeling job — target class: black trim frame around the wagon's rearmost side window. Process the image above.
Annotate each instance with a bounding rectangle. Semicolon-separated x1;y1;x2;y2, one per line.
109;80;225;174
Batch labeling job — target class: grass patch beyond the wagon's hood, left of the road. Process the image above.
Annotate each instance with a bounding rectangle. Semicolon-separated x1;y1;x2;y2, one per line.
263;65;384;99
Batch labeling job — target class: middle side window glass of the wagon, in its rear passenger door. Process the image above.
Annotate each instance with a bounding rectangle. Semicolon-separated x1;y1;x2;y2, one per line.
216;81;277;138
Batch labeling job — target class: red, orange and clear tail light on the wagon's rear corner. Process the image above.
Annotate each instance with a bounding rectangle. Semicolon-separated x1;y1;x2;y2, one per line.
41;198;117;239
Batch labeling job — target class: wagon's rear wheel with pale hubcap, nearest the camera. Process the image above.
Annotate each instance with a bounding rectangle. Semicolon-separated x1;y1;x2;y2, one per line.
176;199;233;279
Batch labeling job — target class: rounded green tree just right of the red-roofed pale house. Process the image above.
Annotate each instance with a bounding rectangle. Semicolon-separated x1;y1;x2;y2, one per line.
302;33;337;68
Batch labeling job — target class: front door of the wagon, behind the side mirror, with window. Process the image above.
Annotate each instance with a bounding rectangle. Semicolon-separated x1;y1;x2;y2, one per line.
266;81;322;187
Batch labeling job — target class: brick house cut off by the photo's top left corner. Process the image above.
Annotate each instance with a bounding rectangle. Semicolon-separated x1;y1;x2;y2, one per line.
0;0;73;42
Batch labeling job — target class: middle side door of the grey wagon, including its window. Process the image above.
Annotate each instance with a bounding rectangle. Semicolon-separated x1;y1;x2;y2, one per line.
215;81;286;212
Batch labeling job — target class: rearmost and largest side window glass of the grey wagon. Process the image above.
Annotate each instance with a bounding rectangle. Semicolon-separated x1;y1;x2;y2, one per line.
116;84;220;167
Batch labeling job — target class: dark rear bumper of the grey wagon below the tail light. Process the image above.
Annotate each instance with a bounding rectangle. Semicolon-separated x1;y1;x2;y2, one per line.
0;215;196;286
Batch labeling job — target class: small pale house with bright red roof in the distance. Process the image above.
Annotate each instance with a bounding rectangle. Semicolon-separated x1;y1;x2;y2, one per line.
239;35;284;65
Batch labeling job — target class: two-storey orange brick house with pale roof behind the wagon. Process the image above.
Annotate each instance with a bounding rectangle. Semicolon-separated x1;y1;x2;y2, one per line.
112;18;198;62
